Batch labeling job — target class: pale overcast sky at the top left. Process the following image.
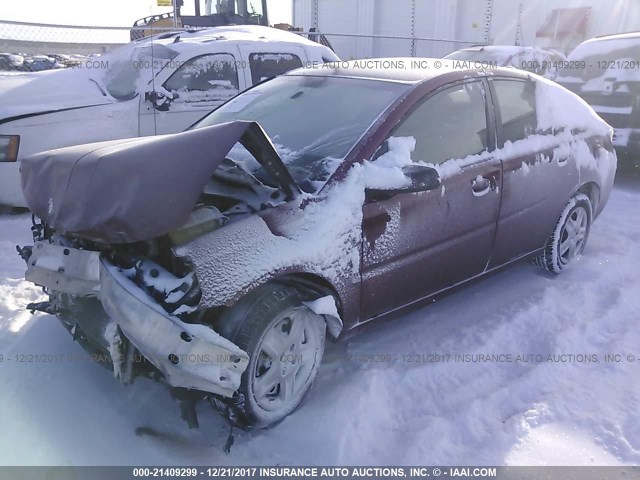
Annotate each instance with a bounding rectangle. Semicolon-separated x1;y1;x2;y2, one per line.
0;0;292;27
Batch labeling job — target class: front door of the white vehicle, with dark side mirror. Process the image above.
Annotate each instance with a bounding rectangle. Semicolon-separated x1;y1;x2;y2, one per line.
140;50;246;136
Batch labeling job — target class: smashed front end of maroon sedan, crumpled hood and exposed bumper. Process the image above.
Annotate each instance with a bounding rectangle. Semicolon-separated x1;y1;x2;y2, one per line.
18;122;299;426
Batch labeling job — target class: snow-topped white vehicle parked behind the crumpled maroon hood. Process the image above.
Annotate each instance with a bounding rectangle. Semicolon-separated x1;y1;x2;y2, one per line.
0;25;339;207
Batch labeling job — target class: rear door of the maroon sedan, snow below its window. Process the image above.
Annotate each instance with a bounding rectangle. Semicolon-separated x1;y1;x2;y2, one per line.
489;78;578;268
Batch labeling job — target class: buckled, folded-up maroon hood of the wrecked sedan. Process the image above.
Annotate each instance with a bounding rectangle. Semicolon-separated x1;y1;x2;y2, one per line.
20;121;299;244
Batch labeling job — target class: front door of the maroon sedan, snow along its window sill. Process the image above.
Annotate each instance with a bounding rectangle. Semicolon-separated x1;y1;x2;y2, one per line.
361;79;501;320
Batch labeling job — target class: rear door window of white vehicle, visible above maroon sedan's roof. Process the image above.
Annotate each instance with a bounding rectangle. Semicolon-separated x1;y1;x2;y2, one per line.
238;42;308;85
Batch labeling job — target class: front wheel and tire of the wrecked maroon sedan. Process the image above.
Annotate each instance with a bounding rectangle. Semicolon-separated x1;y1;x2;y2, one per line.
216;284;327;428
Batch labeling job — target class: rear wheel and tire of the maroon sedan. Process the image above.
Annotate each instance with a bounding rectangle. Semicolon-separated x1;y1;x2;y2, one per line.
533;193;593;273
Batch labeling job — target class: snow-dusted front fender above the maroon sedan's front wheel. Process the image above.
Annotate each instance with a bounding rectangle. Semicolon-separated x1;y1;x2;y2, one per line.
175;216;359;332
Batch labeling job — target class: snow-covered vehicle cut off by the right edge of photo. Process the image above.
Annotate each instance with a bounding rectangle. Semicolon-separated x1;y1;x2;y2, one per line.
555;33;640;168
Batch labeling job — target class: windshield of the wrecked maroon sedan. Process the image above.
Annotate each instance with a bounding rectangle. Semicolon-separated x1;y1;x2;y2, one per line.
194;75;409;192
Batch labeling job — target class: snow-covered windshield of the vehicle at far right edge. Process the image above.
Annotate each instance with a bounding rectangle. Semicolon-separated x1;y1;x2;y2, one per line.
556;38;640;83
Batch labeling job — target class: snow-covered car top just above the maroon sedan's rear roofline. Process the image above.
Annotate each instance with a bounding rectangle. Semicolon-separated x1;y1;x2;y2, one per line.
444;45;565;78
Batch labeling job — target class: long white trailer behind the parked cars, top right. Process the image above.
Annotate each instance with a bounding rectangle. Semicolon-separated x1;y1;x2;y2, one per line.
293;0;640;59
